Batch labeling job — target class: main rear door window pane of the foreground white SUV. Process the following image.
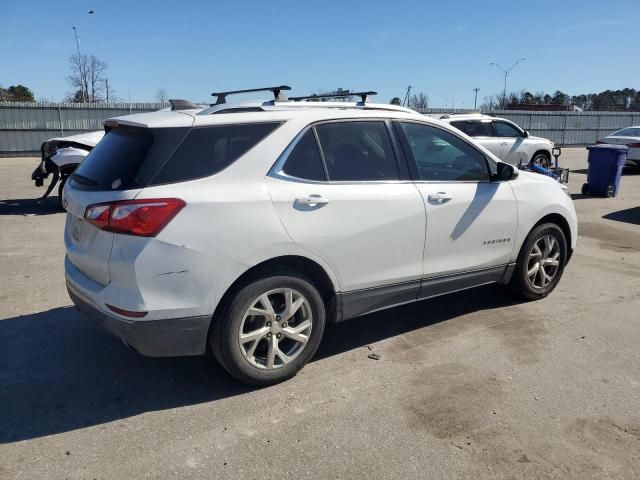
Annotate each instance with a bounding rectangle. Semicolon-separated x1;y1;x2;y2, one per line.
316;122;400;181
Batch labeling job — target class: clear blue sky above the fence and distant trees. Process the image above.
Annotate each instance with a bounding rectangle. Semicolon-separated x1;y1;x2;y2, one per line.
0;0;640;107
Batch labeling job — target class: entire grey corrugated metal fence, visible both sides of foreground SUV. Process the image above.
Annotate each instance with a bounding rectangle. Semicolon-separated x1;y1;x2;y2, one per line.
0;102;640;156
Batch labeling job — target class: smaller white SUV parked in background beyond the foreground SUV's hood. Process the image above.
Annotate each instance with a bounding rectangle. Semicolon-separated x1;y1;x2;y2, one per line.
441;113;554;168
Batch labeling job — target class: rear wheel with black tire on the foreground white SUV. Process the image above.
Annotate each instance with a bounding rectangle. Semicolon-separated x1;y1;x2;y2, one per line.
209;272;326;386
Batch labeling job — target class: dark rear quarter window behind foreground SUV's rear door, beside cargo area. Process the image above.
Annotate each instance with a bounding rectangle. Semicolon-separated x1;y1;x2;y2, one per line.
151;123;280;185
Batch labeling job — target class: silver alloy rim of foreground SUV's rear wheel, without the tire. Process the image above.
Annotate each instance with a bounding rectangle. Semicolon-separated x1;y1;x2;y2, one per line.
238;288;313;370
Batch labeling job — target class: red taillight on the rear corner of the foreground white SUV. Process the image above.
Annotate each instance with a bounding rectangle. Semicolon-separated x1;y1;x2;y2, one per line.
84;198;186;237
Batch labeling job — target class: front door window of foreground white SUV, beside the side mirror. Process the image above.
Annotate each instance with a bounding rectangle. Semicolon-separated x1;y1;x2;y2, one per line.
400;123;489;181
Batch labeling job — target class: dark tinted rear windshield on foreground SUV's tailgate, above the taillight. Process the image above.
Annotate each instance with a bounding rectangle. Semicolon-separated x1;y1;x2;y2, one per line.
72;127;153;190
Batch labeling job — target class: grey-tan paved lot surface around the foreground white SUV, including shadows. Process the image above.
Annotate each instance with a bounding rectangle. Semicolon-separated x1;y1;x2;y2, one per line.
0;149;640;480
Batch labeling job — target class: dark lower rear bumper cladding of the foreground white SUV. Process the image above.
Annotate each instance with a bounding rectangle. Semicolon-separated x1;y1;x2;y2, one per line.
67;281;211;357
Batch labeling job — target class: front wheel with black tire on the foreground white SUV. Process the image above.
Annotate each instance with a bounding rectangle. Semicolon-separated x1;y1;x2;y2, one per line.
509;223;567;300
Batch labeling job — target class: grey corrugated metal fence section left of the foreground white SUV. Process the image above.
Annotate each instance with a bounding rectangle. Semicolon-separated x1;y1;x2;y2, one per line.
0;102;162;156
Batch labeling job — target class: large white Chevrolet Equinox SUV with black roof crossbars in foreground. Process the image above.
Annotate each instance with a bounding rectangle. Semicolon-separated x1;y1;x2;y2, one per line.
63;88;577;385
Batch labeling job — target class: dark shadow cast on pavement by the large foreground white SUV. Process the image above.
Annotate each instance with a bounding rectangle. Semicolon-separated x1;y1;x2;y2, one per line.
0;286;512;443
